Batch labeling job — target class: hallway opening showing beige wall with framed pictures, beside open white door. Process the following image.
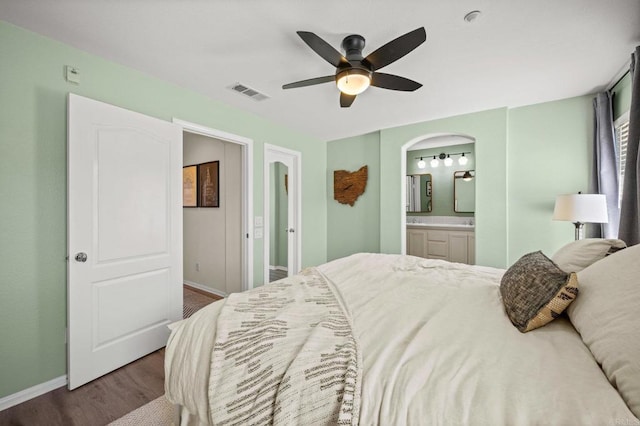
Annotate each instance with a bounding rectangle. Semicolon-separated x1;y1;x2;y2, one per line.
182;132;243;297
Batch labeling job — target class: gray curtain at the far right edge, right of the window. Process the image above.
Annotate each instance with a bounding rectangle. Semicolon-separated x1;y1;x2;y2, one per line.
618;46;640;246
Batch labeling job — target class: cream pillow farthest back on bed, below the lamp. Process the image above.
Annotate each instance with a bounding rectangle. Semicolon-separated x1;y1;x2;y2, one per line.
551;238;627;272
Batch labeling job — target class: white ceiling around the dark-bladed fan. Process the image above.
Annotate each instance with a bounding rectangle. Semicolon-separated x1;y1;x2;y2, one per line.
0;0;640;140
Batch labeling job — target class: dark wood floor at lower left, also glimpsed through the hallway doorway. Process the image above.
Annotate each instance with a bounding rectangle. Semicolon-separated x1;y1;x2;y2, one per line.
0;286;218;426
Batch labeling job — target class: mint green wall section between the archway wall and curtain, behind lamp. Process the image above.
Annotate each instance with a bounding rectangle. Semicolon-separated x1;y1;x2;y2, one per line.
507;96;593;264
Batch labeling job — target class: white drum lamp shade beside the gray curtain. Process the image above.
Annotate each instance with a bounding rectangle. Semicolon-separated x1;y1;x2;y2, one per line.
553;194;609;223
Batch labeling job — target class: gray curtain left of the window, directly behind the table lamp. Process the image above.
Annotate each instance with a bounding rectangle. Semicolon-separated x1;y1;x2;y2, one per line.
587;91;620;238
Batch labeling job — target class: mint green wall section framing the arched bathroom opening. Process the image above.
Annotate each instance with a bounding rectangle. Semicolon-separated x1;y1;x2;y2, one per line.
380;108;507;266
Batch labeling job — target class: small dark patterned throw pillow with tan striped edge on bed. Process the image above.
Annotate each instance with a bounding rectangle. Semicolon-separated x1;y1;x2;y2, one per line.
500;251;578;333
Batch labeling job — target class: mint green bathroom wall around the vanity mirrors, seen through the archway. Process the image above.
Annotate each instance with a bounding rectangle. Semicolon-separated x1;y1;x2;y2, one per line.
407;143;476;217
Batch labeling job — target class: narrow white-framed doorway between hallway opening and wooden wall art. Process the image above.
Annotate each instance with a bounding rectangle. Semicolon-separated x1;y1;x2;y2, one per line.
264;144;301;283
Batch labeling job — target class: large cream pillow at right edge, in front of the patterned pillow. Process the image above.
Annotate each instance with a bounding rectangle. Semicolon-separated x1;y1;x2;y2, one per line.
567;245;640;417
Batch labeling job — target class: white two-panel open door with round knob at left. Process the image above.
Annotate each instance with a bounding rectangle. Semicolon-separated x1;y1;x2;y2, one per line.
67;94;182;389
